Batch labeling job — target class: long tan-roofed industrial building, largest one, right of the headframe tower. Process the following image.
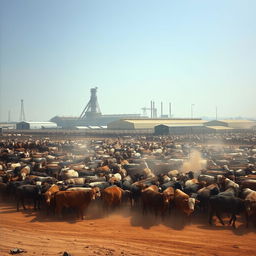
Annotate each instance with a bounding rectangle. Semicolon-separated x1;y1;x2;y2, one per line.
107;118;206;130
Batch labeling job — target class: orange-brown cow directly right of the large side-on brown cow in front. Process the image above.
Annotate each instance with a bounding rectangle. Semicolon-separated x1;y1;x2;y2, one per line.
102;185;132;211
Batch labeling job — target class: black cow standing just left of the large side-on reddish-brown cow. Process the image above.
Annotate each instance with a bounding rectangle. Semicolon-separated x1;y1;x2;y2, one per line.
16;185;42;211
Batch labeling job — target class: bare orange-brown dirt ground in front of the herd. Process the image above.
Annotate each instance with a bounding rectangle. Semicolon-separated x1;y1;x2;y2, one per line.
0;202;256;256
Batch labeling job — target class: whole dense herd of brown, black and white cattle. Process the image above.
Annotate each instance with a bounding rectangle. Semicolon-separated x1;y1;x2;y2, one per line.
0;136;256;227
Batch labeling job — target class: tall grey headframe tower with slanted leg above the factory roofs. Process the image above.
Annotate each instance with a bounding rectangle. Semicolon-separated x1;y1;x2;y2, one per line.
79;87;101;119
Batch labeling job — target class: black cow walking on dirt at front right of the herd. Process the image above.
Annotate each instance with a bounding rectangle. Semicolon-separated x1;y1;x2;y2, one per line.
209;194;245;228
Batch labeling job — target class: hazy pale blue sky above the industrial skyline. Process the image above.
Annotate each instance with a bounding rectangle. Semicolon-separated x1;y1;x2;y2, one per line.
0;0;256;121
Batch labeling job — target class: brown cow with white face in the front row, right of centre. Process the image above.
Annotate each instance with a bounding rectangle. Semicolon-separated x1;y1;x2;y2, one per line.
174;189;199;215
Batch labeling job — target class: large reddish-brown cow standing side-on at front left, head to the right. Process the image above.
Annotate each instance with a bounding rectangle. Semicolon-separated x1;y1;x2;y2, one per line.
55;187;100;219
